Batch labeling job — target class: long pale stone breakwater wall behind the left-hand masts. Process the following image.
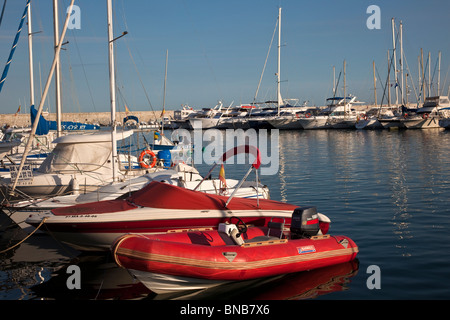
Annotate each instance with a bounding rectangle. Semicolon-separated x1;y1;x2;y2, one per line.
0;110;173;127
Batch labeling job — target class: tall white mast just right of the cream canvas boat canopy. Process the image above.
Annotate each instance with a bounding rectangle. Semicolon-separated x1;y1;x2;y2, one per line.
107;0;117;181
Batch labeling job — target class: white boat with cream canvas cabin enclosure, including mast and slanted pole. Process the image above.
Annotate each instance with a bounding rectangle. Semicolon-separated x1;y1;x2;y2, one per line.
0;1;171;201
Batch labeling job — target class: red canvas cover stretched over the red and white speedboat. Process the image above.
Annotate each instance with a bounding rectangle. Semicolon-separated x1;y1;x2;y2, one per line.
52;181;298;215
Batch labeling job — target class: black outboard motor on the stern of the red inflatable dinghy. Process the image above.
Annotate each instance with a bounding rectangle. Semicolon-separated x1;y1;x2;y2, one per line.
291;207;320;239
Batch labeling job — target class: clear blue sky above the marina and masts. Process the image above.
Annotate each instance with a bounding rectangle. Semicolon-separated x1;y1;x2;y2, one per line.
0;0;450;113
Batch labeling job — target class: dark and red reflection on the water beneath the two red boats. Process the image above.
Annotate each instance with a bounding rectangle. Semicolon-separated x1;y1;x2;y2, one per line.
31;255;359;300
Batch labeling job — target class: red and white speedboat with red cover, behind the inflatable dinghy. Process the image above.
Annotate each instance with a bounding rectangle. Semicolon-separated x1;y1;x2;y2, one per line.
25;146;330;251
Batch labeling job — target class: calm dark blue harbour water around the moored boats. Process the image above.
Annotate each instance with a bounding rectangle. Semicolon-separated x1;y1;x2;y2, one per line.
0;130;450;300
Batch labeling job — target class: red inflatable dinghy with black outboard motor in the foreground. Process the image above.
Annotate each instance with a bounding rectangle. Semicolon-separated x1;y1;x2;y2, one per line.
112;207;358;293
